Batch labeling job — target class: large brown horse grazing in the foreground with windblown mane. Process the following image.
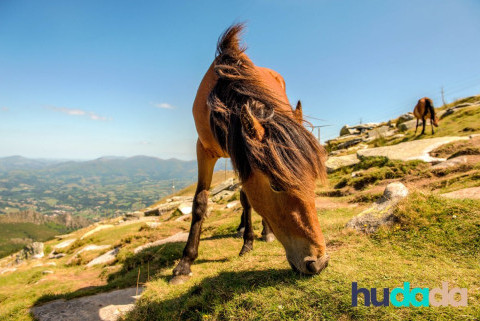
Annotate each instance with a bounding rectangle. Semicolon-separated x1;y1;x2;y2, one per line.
171;24;328;284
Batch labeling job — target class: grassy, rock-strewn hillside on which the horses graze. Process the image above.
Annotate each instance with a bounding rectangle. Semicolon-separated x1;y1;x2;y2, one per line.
0;96;480;320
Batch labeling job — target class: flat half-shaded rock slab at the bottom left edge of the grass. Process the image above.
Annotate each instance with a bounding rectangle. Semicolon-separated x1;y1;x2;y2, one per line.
31;288;143;321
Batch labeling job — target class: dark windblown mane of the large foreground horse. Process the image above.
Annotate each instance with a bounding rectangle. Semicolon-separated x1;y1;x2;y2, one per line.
207;24;326;195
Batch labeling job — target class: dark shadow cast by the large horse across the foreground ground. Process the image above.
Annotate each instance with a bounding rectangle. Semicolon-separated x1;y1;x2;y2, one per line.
30;236;300;321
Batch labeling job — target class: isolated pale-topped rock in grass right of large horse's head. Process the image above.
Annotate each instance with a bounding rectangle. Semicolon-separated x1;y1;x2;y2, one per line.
345;182;408;233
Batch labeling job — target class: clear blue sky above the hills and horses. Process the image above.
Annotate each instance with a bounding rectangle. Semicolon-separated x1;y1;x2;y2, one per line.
0;0;480;159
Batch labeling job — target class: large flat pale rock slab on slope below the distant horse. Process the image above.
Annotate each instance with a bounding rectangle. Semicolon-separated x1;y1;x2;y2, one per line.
357;136;469;162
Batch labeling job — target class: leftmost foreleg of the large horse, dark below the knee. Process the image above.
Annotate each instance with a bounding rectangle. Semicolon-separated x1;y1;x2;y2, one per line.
170;141;218;284
